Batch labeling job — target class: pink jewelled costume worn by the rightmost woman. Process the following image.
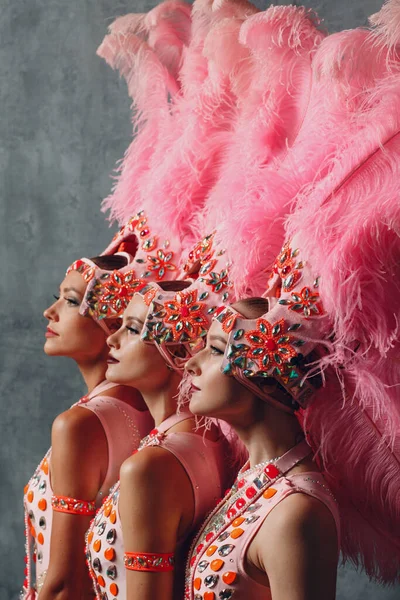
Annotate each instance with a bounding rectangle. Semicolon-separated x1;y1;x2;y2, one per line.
185;441;340;600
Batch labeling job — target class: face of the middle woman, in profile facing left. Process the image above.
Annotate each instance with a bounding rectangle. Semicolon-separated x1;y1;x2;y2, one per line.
106;294;171;392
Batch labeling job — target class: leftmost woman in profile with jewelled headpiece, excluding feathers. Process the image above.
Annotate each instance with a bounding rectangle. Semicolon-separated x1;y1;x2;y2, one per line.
23;221;162;600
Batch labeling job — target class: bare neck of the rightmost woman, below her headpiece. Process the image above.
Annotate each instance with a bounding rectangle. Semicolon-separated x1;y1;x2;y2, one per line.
233;400;302;467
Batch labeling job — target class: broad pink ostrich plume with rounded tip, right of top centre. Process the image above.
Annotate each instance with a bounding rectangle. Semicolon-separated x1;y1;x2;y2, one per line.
203;6;324;297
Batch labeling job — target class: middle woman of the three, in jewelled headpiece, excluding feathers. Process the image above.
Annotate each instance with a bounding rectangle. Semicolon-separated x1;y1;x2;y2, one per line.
87;241;242;600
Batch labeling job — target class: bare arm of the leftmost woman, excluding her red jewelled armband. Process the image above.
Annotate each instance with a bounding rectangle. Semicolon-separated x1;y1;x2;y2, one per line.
40;407;108;600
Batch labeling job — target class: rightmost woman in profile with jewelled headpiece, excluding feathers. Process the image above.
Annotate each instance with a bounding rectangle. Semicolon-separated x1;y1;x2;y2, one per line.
186;240;339;600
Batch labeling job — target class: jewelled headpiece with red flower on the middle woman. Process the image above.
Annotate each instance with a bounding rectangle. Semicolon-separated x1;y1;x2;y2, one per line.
138;234;232;371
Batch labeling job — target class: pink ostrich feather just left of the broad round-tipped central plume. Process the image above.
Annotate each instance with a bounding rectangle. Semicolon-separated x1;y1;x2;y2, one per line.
136;1;256;255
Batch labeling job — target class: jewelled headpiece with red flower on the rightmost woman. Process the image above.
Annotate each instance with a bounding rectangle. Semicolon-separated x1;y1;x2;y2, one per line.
215;234;329;411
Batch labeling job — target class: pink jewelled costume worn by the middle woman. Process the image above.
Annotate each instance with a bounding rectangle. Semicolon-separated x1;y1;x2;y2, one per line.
86;411;233;600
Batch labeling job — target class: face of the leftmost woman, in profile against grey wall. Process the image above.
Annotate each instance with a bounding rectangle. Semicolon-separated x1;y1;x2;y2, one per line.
43;271;108;363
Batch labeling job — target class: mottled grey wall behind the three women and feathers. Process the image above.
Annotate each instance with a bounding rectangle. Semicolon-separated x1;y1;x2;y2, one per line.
0;0;400;600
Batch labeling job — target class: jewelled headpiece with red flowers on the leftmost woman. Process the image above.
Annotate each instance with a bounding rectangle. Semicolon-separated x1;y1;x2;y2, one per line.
75;211;180;334
